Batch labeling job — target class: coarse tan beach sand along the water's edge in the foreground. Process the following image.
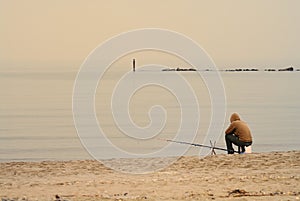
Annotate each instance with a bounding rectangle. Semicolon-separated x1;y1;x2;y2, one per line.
0;151;300;201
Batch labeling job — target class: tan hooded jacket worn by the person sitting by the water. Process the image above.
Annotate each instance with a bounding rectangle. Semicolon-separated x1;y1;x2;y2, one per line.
225;113;252;142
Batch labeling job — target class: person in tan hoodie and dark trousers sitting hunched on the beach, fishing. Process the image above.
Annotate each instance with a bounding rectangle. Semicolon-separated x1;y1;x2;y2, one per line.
225;113;252;154
